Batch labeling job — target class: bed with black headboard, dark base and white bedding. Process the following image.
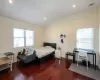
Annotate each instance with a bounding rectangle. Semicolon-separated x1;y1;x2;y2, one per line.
35;42;56;64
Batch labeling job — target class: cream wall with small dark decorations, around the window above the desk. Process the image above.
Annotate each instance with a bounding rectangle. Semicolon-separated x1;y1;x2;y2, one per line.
45;7;99;64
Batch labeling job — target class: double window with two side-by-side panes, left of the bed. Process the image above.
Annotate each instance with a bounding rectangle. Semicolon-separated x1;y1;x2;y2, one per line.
13;28;34;48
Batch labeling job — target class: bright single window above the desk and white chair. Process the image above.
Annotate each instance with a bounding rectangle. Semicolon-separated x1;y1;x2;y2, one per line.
76;28;94;50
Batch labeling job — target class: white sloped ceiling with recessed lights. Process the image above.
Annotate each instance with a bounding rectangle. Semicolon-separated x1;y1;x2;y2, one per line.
0;0;100;24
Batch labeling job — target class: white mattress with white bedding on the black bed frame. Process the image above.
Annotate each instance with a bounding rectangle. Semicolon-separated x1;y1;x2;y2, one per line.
34;47;55;58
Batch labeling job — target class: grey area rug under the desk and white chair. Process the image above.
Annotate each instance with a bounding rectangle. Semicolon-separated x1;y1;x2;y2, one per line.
69;64;100;80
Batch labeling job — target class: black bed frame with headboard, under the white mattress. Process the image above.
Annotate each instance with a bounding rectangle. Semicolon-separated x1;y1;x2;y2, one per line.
38;42;56;64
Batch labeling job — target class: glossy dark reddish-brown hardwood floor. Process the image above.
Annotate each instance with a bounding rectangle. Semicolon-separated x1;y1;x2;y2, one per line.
0;59;93;80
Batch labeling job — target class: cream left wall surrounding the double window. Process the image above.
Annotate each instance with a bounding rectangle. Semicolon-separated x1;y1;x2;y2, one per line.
0;16;44;61
